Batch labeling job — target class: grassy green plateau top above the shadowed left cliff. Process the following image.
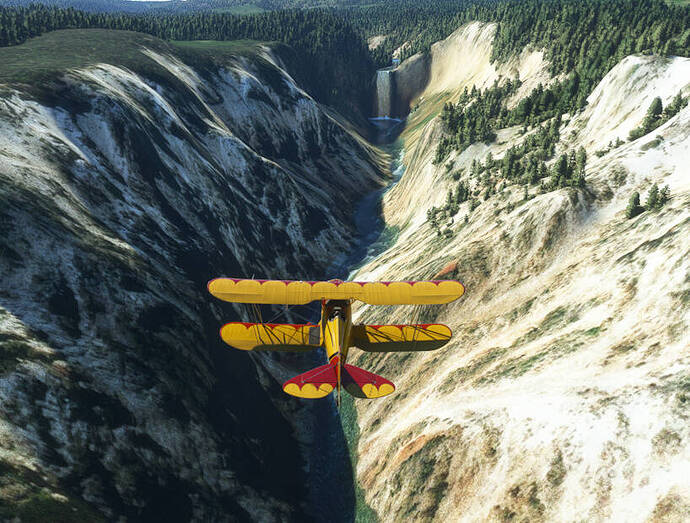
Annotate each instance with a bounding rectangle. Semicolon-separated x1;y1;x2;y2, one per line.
0;29;258;83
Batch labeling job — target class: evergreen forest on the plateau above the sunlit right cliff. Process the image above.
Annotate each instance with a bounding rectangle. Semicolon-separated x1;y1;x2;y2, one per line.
347;0;690;88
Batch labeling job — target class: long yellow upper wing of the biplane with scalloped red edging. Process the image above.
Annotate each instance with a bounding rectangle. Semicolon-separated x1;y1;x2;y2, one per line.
208;278;465;305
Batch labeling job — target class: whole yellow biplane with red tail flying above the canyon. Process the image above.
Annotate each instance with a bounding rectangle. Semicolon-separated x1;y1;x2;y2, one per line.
208;278;465;404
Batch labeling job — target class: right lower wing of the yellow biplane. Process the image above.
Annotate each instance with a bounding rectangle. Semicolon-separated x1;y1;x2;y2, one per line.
352;323;452;352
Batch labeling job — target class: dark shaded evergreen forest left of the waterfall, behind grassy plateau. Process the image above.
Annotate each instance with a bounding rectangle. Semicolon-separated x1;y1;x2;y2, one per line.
0;4;374;115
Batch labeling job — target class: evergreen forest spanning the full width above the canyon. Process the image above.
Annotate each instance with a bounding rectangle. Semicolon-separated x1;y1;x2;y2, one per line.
0;0;690;119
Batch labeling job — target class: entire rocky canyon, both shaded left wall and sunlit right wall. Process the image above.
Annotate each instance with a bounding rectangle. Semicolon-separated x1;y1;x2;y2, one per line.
0;16;690;521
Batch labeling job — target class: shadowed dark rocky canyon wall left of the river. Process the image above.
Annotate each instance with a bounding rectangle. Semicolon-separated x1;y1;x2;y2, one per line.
0;35;382;521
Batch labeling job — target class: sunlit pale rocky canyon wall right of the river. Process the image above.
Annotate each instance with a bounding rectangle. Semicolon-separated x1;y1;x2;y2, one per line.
353;24;690;521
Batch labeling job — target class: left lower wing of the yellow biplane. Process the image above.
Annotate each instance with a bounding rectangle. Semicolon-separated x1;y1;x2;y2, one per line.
220;322;321;352
